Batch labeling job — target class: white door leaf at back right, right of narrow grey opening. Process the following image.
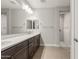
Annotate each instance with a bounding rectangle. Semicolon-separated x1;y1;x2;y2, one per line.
64;12;71;47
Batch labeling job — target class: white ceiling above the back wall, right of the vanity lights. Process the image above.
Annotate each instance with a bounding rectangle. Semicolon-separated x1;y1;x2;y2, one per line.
28;0;70;8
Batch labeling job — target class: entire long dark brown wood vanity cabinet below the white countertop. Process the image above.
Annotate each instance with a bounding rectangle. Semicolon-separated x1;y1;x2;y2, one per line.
1;34;40;59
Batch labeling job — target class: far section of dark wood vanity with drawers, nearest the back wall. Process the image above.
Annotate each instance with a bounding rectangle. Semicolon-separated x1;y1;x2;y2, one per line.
29;35;40;59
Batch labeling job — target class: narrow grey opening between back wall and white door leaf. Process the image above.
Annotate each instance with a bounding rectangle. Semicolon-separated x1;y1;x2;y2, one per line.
59;14;64;46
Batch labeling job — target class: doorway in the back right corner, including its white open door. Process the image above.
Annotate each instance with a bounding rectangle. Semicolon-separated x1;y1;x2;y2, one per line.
59;11;71;47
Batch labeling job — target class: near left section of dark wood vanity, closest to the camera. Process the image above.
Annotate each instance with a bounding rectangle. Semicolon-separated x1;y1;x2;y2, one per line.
1;40;29;59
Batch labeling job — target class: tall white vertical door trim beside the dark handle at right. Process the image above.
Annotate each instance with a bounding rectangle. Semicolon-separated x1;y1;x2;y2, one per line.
70;0;75;59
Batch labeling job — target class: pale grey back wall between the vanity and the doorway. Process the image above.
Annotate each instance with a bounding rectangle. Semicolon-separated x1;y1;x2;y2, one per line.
35;8;59;46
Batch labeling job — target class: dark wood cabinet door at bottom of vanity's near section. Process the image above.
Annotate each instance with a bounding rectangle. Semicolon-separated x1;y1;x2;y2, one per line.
12;48;28;59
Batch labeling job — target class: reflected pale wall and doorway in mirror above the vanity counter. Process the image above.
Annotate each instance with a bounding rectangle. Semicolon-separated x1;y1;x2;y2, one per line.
1;8;27;35
